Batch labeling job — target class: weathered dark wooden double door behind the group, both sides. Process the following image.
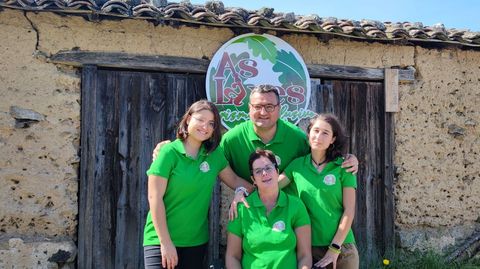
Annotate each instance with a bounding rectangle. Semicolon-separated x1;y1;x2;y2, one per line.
78;65;394;268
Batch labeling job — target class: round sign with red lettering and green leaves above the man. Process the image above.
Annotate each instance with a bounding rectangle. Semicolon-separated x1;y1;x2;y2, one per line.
206;34;314;129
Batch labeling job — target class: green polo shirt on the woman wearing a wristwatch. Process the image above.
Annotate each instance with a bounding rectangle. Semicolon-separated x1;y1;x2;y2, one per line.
284;154;357;246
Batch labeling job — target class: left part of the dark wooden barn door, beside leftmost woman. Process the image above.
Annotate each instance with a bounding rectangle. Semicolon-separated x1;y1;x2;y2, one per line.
78;66;205;269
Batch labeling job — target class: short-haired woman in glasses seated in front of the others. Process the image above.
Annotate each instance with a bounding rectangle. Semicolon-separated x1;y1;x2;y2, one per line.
225;149;312;269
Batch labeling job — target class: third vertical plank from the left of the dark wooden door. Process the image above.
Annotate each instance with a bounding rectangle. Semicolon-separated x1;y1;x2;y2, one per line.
114;70;142;268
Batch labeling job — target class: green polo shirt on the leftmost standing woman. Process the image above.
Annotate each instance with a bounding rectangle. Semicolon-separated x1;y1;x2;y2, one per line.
143;139;228;247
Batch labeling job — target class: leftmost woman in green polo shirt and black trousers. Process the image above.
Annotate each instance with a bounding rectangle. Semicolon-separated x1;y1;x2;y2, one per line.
143;100;253;269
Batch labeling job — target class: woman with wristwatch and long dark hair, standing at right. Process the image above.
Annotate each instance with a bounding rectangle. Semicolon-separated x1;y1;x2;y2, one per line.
280;114;359;269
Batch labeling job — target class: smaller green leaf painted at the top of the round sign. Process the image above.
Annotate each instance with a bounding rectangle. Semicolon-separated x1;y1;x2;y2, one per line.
232;35;277;64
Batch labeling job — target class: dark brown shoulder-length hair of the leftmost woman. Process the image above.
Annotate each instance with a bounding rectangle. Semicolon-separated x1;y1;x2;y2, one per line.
177;100;222;152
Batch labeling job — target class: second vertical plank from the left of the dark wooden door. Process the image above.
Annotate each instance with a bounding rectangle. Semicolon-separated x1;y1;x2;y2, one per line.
94;70;117;269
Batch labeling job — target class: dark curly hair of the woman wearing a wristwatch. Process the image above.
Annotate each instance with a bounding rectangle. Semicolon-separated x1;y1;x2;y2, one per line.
307;113;348;161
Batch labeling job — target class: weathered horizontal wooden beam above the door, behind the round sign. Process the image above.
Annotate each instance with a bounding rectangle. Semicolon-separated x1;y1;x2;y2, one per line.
50;51;415;83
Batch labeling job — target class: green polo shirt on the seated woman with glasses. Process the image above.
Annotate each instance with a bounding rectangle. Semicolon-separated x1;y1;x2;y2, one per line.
227;191;310;269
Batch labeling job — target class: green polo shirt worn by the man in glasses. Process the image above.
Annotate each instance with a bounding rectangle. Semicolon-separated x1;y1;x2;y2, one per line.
221;119;310;194
